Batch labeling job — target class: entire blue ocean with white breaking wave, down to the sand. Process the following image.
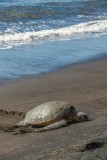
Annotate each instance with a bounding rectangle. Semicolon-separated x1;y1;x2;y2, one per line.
0;0;107;79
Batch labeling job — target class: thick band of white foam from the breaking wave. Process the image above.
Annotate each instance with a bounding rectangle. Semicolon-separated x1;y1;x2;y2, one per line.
0;20;107;46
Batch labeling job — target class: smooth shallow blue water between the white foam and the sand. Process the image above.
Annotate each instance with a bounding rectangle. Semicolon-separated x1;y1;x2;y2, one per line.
0;35;107;80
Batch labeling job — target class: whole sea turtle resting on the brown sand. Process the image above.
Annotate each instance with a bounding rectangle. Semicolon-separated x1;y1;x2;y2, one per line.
16;101;88;132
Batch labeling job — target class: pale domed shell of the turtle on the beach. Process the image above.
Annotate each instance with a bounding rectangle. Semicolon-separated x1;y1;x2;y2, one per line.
24;101;75;126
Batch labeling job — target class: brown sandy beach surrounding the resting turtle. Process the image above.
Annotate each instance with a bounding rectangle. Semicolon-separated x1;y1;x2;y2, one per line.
0;57;107;160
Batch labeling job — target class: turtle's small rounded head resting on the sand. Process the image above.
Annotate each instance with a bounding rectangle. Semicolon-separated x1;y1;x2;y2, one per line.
75;112;89;122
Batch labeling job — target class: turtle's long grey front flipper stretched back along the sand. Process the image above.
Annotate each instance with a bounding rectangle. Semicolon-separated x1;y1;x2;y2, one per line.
35;119;68;132
